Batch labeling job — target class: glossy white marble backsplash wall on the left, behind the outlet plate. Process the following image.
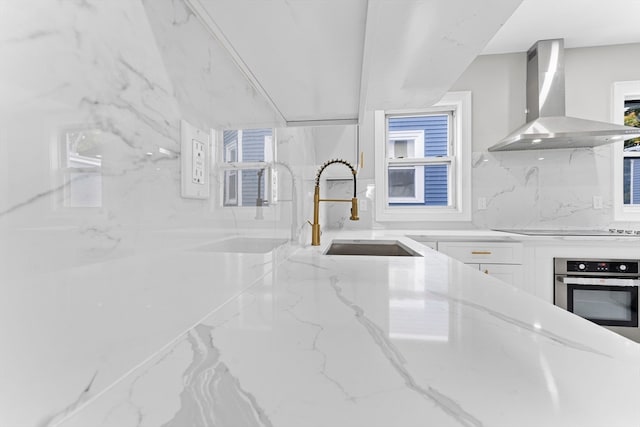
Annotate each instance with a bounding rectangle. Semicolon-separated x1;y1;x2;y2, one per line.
0;0;302;427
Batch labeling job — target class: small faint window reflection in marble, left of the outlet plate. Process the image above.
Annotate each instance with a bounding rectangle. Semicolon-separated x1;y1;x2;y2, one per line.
59;129;102;208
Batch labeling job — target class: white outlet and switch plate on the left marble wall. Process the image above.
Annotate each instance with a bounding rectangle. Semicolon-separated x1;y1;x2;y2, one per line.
180;120;210;199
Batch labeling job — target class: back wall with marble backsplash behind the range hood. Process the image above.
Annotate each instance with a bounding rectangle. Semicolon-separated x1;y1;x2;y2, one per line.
331;44;640;228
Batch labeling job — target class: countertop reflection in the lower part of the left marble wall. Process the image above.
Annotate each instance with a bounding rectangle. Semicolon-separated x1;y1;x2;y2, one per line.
0;234;296;427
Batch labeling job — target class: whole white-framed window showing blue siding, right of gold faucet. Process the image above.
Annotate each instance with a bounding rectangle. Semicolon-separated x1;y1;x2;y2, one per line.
374;92;471;221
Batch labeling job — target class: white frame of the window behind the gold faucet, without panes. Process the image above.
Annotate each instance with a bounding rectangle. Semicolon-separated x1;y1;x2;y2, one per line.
374;91;472;222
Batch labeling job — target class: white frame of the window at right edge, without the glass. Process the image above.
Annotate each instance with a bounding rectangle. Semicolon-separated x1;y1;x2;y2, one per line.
611;80;640;221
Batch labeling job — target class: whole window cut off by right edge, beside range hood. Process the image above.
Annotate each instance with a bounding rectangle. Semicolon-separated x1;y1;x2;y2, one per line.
612;81;640;221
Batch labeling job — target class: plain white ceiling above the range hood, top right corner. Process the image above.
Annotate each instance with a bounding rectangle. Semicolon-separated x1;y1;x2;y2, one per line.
482;0;640;54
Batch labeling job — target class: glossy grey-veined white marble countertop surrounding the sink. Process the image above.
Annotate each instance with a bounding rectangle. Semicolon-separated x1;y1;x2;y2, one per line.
49;231;640;427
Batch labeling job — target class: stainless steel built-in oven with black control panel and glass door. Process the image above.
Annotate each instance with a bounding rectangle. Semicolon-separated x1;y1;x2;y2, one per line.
553;258;640;342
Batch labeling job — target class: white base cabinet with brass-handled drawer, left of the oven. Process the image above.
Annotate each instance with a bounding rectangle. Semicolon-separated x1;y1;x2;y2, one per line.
437;241;524;287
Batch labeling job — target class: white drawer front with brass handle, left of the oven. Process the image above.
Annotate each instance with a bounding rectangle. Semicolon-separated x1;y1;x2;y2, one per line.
438;242;522;264
